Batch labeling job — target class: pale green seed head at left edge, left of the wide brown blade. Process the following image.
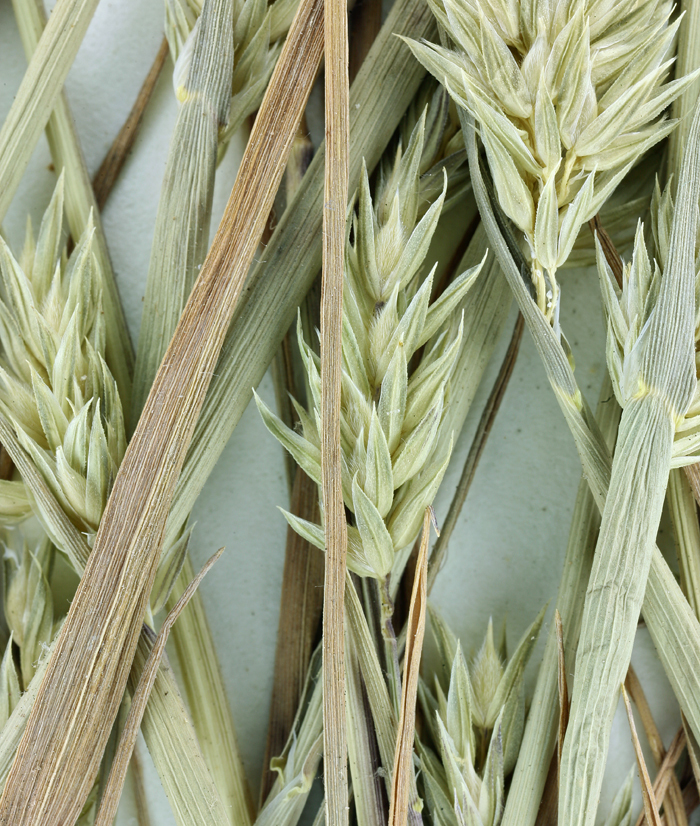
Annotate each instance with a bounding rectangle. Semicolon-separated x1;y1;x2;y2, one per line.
0;177;126;535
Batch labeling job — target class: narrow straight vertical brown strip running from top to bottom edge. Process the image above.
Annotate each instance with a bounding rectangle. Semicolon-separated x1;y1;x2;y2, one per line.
321;0;350;826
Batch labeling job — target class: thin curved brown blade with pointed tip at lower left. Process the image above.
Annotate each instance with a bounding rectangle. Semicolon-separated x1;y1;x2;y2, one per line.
95;548;224;826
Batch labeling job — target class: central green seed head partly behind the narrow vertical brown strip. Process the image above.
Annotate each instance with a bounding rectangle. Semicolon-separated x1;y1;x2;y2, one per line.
256;104;481;586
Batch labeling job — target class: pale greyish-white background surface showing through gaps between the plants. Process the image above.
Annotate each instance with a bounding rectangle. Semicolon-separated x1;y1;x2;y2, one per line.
0;0;679;826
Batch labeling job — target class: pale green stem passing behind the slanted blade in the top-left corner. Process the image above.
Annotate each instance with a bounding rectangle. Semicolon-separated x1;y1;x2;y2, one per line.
11;0;134;410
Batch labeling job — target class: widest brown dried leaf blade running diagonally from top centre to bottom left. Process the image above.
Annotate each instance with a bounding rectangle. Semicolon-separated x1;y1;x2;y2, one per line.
0;0;322;812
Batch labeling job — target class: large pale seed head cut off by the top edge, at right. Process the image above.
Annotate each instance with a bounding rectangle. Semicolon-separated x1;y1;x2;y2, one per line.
409;0;695;319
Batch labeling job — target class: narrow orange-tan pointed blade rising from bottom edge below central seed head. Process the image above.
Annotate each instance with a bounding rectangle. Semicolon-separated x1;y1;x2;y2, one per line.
389;508;430;826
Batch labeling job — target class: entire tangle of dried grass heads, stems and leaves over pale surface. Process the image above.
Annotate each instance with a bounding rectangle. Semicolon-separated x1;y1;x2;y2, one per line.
0;0;700;826
